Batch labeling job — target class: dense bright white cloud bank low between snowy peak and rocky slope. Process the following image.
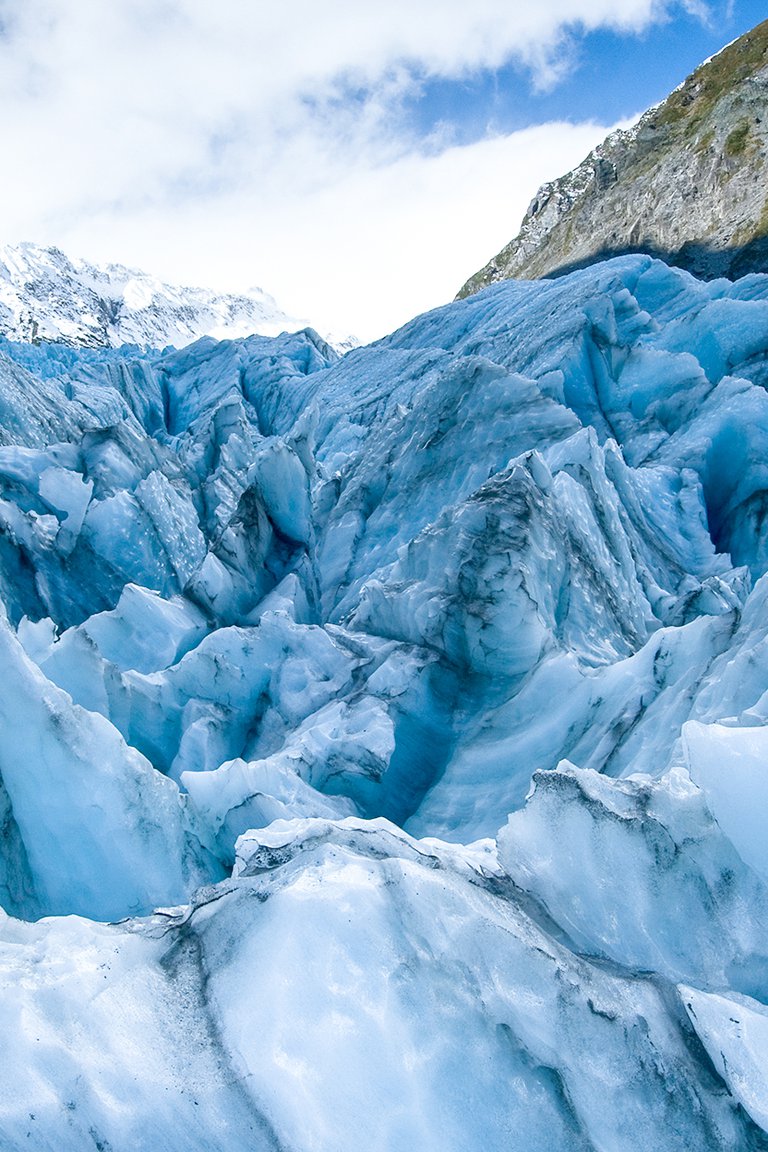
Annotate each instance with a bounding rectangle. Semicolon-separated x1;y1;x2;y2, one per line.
50;123;630;339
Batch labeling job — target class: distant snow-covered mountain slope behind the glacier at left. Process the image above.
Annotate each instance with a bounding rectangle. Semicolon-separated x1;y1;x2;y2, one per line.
0;243;315;348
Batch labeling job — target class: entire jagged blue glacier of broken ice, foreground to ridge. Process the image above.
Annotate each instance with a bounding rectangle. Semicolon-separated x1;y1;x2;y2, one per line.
0;257;768;1152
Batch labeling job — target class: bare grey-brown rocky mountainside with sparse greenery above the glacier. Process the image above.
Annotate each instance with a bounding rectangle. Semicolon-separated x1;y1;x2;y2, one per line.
458;21;768;297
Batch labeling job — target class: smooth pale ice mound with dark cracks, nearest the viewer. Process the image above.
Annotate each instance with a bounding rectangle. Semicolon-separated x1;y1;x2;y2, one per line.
0;819;765;1152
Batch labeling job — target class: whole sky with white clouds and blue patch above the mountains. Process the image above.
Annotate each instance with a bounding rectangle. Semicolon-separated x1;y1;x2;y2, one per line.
0;0;768;340
